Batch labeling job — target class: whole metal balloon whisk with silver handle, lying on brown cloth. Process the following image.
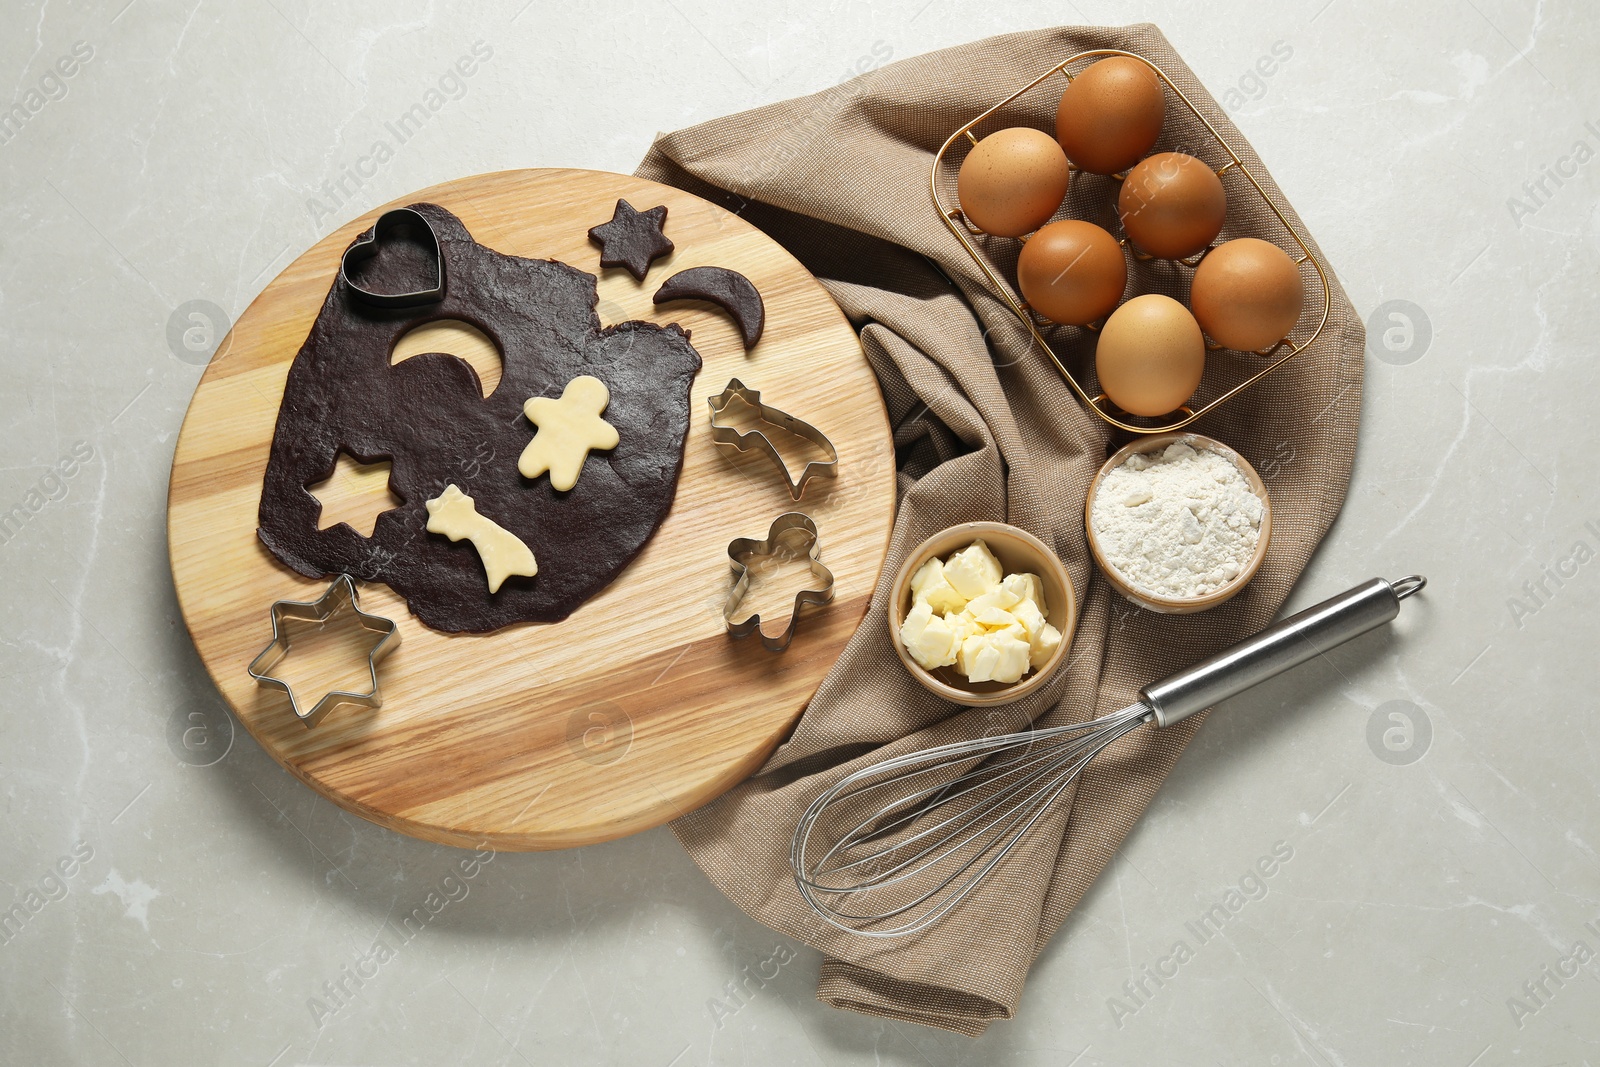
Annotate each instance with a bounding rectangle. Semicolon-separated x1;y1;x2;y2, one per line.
789;574;1427;937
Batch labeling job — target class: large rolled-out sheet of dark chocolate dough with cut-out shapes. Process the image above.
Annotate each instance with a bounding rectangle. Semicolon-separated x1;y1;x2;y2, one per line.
258;203;701;633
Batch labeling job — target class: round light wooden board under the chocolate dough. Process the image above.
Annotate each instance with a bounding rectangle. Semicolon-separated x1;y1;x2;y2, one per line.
166;170;894;851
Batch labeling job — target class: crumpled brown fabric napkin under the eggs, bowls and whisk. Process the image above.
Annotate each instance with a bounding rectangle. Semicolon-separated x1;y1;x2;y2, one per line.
638;26;1365;1037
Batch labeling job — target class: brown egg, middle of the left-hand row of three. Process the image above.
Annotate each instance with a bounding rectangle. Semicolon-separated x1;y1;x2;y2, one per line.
1016;219;1128;326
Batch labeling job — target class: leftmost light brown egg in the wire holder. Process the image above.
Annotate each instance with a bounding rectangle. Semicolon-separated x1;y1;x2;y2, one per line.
955;126;1069;237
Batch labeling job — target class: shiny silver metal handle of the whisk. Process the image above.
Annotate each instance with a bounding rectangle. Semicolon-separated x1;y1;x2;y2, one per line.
1139;574;1427;726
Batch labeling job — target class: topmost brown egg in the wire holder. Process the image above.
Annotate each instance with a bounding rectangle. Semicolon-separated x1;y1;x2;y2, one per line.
1056;56;1165;174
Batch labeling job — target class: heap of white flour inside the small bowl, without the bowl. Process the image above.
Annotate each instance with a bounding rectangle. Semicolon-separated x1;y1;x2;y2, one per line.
1091;442;1262;598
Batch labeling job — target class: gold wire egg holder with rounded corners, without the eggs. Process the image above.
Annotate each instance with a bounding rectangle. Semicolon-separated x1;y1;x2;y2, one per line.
928;48;1333;434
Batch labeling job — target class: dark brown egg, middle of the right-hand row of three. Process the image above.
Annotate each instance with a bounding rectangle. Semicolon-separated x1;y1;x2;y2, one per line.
1117;152;1227;259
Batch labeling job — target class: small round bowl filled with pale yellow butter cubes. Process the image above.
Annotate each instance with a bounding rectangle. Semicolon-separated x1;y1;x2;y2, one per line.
888;523;1077;707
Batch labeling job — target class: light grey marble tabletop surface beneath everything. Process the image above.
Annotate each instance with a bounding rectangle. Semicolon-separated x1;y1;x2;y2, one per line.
0;0;1600;1067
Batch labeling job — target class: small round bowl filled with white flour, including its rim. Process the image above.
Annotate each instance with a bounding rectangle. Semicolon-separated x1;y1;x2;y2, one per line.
1083;434;1272;614
